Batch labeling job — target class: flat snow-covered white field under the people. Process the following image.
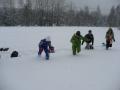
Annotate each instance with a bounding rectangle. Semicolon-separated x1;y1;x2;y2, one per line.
0;27;120;90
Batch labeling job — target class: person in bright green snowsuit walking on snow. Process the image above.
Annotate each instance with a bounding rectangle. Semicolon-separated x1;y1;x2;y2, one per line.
70;31;84;55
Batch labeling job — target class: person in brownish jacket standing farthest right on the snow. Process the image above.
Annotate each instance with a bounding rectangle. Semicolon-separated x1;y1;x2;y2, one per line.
105;27;115;50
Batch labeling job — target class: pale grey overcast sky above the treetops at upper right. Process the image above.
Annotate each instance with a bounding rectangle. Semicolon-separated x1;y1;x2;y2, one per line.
66;0;120;14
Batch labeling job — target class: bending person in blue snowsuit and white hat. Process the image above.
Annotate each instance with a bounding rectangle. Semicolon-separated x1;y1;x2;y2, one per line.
38;36;54;60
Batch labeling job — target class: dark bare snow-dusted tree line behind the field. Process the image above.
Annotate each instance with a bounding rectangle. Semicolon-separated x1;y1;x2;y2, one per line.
0;0;120;27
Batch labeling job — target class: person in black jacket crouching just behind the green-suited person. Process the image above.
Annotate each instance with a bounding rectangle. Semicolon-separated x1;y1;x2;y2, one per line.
84;30;94;49
